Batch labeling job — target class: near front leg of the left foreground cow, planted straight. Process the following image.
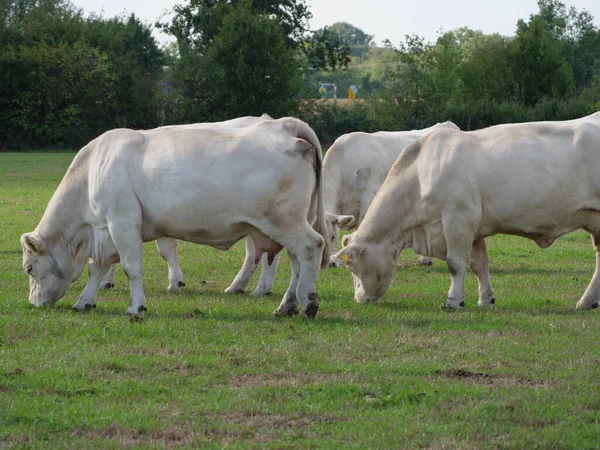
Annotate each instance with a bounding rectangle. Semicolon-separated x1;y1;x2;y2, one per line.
108;222;146;316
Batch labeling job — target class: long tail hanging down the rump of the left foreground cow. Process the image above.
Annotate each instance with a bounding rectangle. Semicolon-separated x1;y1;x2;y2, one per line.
284;119;331;269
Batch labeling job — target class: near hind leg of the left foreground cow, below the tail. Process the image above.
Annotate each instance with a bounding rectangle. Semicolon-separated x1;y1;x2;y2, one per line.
280;223;325;318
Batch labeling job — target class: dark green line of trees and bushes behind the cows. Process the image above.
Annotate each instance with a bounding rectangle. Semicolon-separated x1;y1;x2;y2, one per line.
0;0;600;149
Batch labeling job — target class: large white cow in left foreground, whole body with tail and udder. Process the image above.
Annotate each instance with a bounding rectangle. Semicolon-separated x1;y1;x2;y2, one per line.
21;118;329;317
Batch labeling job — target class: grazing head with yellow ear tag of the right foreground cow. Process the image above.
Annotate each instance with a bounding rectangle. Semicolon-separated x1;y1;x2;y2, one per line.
332;234;400;303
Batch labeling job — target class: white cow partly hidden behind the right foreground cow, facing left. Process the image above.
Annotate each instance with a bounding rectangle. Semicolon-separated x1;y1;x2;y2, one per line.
323;121;459;265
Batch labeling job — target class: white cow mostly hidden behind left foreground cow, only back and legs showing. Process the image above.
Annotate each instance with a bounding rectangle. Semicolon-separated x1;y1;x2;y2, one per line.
72;114;280;295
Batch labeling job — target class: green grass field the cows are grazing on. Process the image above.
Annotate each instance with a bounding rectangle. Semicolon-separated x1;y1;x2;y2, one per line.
0;153;600;449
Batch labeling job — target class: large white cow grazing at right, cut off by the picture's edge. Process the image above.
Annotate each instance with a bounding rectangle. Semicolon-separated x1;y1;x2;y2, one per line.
333;113;600;308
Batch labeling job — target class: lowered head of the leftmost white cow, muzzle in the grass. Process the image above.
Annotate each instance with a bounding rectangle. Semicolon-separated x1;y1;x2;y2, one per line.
21;232;75;306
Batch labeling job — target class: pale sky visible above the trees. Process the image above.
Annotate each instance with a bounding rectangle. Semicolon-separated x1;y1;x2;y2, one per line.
73;0;600;47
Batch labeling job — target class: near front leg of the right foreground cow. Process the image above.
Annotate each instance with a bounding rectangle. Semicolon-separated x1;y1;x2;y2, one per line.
442;212;475;309
